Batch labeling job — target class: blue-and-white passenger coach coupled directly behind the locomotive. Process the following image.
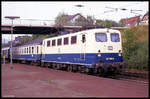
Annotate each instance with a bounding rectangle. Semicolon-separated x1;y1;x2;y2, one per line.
12;39;43;63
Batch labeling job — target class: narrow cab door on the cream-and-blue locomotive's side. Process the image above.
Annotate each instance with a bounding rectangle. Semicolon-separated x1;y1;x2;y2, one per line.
80;33;86;60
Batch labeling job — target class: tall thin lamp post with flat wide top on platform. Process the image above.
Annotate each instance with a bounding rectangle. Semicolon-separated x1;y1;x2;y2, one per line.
5;16;20;69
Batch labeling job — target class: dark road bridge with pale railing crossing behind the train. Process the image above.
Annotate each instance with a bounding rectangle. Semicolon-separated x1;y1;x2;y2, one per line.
1;19;82;34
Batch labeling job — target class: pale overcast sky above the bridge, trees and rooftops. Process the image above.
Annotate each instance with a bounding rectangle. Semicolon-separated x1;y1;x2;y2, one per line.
1;1;149;42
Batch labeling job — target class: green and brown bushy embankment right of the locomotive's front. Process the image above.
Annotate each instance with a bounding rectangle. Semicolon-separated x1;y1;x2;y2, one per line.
122;26;149;70
